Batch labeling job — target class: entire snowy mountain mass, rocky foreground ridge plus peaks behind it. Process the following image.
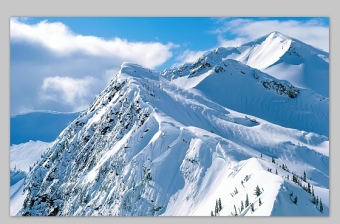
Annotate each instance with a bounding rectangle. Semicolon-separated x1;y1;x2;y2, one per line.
11;32;329;216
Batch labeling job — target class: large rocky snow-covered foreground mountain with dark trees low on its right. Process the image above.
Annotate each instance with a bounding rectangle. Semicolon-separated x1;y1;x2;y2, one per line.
18;63;329;216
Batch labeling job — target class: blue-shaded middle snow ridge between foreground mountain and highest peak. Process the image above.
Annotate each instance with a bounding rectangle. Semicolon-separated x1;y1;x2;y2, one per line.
162;57;329;136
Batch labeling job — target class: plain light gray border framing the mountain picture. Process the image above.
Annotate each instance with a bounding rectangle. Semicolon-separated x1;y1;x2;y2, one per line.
0;0;340;224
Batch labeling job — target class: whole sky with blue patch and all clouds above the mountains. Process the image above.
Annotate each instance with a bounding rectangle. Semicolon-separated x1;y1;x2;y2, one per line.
10;17;329;115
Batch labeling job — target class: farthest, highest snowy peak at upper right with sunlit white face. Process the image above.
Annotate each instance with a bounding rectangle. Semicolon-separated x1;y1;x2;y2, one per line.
232;32;329;98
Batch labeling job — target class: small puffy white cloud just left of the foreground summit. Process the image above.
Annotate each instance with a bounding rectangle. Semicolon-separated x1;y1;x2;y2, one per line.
40;76;97;110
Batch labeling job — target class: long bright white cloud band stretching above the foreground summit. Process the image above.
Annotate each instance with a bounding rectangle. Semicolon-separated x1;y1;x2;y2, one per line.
10;18;176;69
